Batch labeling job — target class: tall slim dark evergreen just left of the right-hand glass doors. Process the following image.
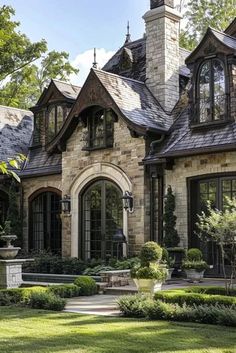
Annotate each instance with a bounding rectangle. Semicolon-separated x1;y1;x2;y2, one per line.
163;186;180;248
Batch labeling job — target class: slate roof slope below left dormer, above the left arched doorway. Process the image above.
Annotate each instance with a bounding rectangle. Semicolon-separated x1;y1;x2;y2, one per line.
20;147;62;178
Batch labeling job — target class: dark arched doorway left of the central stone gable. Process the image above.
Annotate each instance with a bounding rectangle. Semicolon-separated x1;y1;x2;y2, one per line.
29;190;61;254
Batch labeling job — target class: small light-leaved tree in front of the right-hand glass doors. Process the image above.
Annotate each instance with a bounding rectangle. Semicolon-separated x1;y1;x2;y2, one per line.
196;198;236;294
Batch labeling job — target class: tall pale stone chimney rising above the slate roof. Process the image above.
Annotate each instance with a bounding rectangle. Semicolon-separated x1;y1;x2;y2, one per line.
143;0;181;112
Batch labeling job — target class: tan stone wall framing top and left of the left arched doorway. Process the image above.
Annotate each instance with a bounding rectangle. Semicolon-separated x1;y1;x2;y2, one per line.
21;175;62;250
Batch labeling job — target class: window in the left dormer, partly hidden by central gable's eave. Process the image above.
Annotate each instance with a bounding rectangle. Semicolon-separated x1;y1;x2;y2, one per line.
46;105;67;143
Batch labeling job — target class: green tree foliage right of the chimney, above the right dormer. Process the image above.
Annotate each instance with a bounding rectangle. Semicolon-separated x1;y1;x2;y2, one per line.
180;0;236;50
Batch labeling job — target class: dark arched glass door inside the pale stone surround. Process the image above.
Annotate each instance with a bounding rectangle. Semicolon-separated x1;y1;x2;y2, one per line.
80;179;123;260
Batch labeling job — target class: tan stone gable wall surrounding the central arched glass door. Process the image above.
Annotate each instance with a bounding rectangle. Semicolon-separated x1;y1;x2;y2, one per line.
62;119;148;256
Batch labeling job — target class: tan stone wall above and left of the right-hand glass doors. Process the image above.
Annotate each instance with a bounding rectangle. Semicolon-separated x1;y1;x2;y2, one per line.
165;152;236;247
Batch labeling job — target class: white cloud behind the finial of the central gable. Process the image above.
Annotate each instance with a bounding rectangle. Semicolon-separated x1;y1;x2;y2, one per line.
70;48;115;86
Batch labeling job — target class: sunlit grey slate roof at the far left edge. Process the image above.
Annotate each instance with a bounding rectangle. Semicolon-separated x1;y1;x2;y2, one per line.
0;106;33;161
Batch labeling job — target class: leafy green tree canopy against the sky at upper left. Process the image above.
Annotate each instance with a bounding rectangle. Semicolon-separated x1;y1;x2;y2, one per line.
0;5;78;109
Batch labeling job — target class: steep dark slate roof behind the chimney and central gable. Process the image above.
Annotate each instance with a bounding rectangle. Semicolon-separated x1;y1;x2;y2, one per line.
102;37;190;82
